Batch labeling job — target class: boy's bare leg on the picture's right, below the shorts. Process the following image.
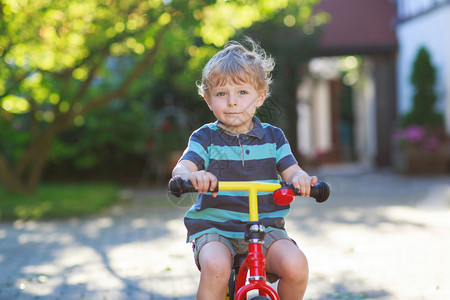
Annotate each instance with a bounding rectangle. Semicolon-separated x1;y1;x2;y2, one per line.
266;239;308;300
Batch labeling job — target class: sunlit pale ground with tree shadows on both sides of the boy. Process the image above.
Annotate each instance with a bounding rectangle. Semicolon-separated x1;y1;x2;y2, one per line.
0;166;450;300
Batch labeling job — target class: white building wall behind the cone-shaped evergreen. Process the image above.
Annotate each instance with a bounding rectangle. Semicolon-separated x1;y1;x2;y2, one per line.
397;0;450;133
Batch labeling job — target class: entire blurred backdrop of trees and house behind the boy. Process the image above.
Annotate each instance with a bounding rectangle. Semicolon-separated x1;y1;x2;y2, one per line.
0;0;450;217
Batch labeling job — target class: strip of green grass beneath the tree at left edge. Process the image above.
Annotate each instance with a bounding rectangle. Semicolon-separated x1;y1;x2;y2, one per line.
0;183;119;220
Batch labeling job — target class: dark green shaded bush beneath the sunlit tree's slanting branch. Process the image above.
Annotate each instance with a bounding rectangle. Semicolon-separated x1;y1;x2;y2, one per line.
49;101;149;171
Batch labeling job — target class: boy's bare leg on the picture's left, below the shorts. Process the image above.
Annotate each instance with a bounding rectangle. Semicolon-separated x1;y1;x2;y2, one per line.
197;241;232;300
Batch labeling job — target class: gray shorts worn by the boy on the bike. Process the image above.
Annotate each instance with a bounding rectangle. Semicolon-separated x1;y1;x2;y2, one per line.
192;230;297;282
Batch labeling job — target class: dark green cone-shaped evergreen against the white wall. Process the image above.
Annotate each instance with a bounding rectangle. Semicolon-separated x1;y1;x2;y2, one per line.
402;47;444;127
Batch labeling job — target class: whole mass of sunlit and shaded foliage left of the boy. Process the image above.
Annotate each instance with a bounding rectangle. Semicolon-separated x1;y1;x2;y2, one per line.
0;0;317;192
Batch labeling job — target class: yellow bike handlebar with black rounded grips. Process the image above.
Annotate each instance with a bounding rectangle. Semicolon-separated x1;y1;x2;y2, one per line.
169;176;330;203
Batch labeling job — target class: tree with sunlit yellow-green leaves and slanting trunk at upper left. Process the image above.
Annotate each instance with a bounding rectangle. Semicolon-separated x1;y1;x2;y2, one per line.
0;0;322;193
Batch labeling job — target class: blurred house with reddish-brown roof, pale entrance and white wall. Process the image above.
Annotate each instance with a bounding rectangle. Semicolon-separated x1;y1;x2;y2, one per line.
298;0;450;170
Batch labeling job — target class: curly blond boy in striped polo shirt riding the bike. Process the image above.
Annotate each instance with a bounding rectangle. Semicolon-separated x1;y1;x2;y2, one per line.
172;39;317;300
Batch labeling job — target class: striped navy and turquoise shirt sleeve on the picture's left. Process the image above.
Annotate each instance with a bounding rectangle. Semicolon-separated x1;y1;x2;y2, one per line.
180;127;209;170
